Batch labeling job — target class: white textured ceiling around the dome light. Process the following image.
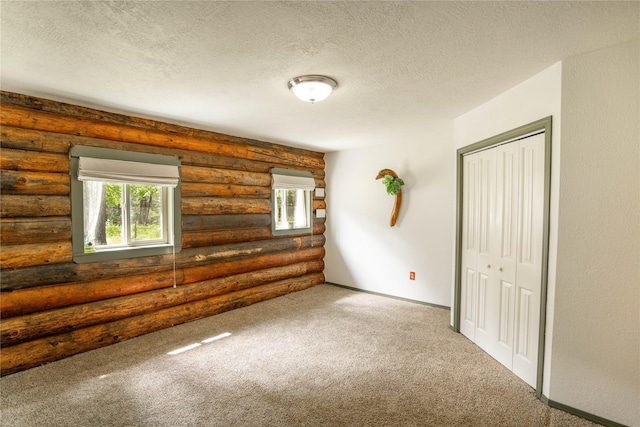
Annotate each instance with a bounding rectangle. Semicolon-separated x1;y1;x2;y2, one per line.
0;0;640;151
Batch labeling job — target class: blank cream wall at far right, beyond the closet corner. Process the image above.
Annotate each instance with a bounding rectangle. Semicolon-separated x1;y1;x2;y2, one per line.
549;41;640;426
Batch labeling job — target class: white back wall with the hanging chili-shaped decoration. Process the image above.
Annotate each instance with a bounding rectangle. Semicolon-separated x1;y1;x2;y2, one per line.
324;124;455;306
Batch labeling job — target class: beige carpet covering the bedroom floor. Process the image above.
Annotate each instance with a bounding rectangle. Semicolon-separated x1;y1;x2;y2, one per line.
0;285;593;427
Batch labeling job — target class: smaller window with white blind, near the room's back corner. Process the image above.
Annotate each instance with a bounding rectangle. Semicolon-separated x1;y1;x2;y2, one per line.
271;168;315;235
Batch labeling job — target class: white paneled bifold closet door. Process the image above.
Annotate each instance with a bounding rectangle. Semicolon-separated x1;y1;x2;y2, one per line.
460;133;545;388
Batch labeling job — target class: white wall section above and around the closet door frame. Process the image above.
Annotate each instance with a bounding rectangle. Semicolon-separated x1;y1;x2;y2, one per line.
451;63;562;396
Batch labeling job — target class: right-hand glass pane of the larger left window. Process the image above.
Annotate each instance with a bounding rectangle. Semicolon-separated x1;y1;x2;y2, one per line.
128;185;165;242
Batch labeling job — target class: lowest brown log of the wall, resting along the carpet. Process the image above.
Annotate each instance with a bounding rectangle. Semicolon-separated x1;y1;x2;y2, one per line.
0;273;324;375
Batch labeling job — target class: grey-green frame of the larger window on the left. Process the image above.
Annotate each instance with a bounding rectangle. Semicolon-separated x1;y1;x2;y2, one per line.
69;145;182;263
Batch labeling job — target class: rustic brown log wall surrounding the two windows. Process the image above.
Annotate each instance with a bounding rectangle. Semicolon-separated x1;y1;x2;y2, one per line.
0;92;326;375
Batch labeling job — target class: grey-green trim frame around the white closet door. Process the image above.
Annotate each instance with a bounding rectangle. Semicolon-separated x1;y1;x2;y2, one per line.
453;116;552;399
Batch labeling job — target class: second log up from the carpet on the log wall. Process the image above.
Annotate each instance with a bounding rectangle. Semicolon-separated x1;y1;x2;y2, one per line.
0;260;324;349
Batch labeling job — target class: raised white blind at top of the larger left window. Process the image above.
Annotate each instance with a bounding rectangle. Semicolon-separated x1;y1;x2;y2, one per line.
78;157;180;188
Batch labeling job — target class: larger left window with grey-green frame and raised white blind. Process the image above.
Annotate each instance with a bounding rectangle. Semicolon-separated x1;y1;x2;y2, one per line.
71;146;181;262
